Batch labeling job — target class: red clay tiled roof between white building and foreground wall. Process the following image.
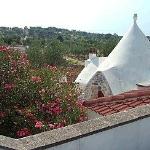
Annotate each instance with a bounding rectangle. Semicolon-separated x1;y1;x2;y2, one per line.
83;90;150;115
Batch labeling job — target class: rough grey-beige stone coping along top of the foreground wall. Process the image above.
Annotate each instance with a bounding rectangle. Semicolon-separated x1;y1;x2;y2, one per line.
0;104;150;150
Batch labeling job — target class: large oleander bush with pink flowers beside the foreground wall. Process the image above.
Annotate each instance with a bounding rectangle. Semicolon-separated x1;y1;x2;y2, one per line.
0;46;87;138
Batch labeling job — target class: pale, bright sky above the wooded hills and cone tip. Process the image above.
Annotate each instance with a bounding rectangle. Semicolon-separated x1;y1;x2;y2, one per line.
0;0;150;35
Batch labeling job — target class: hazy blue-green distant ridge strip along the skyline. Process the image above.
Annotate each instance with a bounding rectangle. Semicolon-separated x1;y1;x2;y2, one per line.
0;27;120;40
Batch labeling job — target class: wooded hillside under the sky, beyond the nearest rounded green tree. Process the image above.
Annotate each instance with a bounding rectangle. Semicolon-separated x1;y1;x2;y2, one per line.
0;27;150;57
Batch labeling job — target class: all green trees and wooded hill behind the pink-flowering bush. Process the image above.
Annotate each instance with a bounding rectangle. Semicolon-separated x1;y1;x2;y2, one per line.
0;27;121;65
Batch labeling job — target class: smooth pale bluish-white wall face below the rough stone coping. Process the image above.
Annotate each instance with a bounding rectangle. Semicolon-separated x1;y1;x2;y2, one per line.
47;118;150;150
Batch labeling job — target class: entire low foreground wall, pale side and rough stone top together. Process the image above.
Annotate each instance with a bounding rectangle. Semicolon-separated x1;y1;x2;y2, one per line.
0;105;150;150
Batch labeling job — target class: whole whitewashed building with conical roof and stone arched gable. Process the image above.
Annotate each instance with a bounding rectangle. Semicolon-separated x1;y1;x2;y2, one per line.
75;14;150;99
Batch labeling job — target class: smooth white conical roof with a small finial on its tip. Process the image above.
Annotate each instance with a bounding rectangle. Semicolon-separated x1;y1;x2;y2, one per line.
98;14;150;94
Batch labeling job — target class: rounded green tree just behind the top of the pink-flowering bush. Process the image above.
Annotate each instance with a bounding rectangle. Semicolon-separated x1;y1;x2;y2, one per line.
27;40;64;66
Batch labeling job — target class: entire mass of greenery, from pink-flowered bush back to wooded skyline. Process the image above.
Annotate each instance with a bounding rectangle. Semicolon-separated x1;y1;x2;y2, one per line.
0;24;150;138
